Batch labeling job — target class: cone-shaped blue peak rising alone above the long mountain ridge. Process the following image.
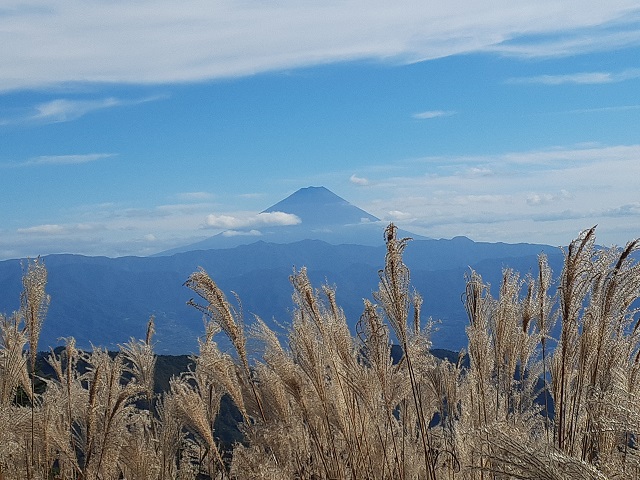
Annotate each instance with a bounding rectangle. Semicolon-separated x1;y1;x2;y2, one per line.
157;187;410;255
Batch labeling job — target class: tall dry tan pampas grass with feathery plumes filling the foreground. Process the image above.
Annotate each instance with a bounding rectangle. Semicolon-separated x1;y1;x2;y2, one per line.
0;225;640;480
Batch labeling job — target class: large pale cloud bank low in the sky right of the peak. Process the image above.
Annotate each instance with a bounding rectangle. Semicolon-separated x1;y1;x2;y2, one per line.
360;144;640;245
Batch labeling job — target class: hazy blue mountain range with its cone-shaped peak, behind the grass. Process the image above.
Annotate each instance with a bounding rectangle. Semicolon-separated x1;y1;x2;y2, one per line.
0;187;562;354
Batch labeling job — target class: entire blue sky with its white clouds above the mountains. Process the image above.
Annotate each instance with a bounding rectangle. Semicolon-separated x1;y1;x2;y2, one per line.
0;0;640;259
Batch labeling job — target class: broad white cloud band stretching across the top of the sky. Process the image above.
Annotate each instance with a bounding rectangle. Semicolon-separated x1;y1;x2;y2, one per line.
0;0;640;91
